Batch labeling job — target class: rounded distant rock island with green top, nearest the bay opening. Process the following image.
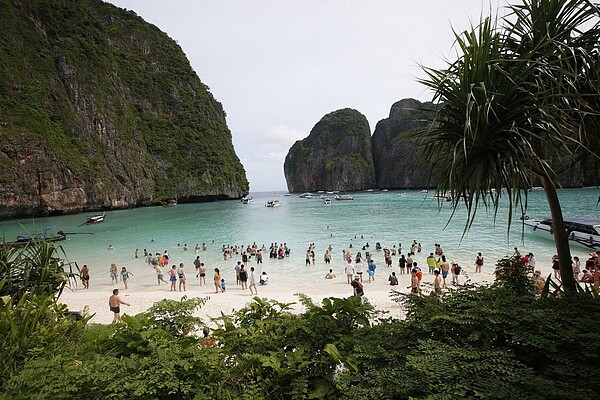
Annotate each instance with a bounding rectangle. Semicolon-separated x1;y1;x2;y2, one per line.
284;108;375;192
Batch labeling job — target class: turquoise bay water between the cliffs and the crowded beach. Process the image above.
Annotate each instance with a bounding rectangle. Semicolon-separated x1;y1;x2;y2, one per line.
0;188;600;282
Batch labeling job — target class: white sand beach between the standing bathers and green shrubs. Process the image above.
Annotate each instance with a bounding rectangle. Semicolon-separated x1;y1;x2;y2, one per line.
60;263;494;324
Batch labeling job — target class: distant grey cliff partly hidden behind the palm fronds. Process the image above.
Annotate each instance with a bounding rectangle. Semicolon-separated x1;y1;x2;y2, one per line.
372;99;434;189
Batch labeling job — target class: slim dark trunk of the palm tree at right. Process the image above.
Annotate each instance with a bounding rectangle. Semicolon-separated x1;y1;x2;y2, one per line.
541;176;577;296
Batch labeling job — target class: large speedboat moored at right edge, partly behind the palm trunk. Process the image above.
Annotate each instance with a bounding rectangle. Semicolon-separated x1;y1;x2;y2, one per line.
523;218;600;250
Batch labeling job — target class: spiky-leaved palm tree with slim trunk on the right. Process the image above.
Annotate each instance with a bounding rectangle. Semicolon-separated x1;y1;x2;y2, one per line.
419;0;600;294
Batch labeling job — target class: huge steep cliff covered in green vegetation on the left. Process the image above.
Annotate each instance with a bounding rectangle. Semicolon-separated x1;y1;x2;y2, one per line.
0;0;248;218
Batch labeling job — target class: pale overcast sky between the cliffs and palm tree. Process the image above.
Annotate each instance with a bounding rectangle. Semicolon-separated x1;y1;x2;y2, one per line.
109;0;505;192
